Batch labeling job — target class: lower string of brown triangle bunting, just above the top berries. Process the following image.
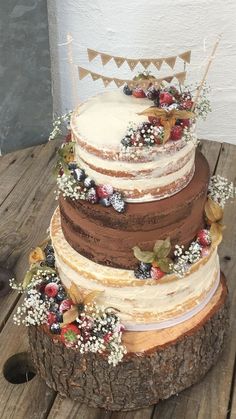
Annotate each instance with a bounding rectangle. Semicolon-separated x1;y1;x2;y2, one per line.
78;66;186;88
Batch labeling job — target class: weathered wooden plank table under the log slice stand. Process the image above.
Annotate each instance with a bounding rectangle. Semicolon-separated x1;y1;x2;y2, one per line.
0;141;236;419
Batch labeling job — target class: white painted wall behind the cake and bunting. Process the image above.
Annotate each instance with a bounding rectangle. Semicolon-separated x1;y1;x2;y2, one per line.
48;0;236;144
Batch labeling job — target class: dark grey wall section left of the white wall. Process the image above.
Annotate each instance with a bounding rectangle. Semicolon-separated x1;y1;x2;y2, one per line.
0;0;52;154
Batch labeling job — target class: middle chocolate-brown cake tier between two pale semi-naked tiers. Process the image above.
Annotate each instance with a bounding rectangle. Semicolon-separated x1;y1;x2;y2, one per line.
59;151;210;269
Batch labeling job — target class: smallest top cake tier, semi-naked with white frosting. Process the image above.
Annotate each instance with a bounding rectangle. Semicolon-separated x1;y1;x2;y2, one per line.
71;90;195;202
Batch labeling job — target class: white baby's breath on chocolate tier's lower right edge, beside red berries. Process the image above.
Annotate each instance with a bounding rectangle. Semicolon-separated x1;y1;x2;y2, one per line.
172;241;202;277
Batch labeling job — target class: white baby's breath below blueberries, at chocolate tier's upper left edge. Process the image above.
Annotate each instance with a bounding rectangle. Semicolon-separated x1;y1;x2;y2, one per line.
57;173;88;200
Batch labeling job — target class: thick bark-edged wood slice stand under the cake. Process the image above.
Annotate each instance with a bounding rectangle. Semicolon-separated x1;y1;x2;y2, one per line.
29;274;229;410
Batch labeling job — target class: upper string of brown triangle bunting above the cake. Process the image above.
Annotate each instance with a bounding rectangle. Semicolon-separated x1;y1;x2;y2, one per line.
87;48;191;71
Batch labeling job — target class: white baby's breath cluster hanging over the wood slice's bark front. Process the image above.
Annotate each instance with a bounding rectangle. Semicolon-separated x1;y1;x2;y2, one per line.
76;303;126;366
